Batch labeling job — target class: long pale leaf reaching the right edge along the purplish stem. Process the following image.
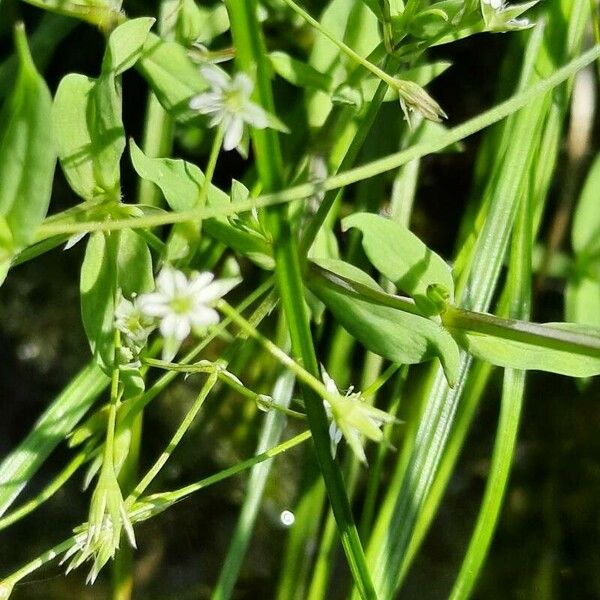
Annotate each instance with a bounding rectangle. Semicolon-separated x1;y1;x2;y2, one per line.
454;323;600;377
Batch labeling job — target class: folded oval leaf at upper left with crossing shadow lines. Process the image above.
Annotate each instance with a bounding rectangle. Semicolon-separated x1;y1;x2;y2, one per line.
52;73;125;202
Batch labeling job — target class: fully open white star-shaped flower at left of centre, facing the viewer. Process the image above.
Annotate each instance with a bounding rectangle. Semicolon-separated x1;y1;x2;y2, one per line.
137;267;239;360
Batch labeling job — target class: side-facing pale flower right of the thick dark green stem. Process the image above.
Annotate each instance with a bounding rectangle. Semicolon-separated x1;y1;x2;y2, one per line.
321;366;396;463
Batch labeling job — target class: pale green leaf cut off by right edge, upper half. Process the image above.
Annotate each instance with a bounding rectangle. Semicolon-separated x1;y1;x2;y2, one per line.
571;154;600;254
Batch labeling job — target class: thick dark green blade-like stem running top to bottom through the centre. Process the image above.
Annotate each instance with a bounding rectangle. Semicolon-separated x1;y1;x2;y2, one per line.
226;0;376;598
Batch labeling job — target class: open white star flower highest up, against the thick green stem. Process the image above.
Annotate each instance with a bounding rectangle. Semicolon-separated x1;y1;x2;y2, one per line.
190;65;269;150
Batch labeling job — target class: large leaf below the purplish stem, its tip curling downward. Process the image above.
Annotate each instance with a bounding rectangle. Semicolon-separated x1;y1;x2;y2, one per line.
308;259;459;386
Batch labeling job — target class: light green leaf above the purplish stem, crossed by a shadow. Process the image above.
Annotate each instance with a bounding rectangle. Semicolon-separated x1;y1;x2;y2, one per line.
342;213;454;315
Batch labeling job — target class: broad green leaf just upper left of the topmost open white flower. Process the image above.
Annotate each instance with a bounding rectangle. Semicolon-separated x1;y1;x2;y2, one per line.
136;33;207;121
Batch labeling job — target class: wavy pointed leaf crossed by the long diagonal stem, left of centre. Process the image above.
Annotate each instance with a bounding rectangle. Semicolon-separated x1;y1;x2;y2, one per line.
130;140;273;269
